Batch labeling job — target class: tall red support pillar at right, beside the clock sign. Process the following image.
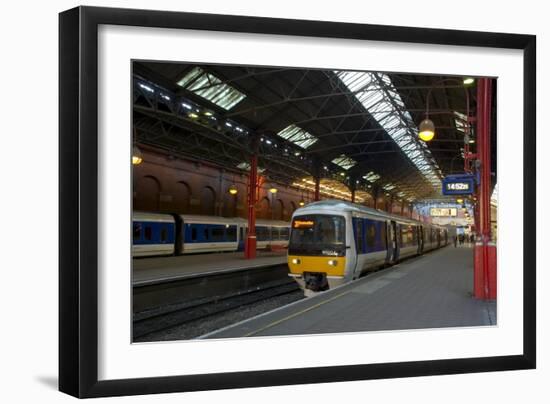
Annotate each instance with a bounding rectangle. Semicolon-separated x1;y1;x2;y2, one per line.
474;79;497;299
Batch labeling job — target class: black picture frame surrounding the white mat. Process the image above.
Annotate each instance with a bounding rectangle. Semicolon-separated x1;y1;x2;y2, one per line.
59;7;536;398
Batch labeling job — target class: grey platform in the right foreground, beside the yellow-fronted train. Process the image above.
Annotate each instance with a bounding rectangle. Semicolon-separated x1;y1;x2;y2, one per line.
201;245;496;338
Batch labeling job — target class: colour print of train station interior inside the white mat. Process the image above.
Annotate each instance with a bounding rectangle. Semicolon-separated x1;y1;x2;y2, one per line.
132;61;498;342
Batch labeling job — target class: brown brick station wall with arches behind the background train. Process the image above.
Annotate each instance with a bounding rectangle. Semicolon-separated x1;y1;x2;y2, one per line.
132;148;416;221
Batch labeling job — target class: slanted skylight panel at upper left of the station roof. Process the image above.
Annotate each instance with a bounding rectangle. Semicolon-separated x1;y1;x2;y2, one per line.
177;67;246;110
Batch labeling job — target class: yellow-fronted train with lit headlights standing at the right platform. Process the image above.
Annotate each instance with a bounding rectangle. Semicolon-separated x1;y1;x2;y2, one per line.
287;200;454;295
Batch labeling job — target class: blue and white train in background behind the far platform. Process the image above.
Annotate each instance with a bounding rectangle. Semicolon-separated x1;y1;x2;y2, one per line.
132;211;290;258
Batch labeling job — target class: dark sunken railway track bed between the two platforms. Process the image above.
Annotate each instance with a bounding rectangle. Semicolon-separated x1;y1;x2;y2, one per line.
133;265;300;342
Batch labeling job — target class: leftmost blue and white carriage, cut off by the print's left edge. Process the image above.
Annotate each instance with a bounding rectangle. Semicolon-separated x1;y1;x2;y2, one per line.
132;212;176;257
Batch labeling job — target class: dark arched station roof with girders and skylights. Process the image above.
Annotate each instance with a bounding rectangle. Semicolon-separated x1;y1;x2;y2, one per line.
133;62;496;202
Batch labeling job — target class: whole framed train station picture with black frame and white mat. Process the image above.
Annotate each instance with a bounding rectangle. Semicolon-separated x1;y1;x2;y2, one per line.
59;7;536;398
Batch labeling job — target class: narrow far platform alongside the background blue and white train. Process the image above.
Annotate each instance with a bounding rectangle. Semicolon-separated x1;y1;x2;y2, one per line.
132;251;286;286
